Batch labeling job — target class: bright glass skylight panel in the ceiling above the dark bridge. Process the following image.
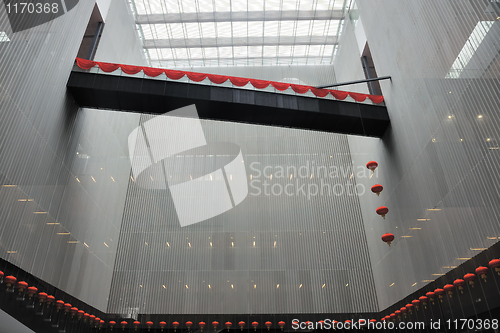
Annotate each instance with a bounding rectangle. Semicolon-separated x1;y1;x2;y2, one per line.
128;0;347;68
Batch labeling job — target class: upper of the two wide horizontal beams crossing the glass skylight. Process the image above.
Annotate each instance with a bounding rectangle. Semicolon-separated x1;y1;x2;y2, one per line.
136;10;343;24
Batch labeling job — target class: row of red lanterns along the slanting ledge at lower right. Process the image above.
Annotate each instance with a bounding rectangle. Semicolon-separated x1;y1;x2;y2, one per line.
382;259;500;320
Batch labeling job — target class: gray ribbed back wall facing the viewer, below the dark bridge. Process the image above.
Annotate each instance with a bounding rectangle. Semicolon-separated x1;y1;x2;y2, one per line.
108;120;376;314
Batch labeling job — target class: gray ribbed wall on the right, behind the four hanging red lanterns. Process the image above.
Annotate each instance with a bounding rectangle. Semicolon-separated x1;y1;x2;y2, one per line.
349;0;500;309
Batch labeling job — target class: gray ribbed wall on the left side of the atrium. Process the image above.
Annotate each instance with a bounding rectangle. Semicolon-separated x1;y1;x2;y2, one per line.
0;1;145;310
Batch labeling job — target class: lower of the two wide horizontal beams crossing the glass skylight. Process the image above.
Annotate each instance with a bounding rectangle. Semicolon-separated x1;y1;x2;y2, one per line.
144;36;337;49
